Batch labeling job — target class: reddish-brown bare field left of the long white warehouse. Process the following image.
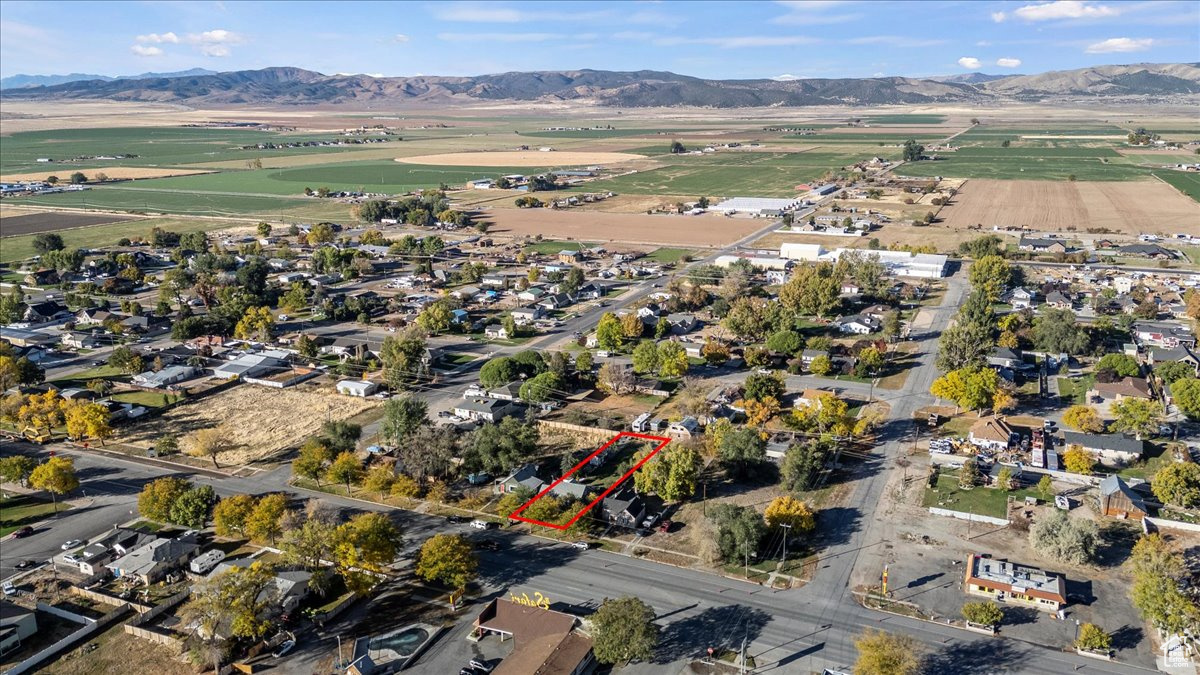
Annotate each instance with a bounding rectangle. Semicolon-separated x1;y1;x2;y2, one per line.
482;209;767;247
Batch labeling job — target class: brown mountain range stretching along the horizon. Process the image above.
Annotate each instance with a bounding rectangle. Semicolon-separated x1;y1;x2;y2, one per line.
0;64;1200;108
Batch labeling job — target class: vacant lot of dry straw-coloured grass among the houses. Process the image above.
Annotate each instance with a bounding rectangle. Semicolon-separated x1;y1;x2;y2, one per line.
118;384;378;465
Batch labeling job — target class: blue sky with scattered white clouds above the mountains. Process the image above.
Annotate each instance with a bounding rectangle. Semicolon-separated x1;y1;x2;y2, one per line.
0;0;1200;78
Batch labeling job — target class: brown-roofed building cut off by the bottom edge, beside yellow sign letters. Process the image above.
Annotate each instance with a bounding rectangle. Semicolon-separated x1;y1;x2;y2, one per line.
470;592;596;675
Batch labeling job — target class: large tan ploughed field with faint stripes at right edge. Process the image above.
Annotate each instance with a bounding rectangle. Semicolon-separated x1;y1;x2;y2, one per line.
940;180;1200;234
